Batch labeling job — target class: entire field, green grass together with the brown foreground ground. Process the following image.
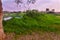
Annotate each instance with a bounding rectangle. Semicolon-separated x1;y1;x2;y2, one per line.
3;11;60;40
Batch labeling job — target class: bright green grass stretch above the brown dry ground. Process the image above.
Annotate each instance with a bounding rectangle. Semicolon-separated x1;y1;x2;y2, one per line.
3;12;60;34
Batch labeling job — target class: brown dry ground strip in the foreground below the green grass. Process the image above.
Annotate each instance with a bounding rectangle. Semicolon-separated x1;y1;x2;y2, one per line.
5;32;60;40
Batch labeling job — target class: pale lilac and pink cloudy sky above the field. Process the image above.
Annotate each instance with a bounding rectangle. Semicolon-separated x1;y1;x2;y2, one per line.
2;0;60;12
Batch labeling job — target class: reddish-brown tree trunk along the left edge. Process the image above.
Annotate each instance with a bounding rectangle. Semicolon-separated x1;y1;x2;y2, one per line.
0;0;5;40
